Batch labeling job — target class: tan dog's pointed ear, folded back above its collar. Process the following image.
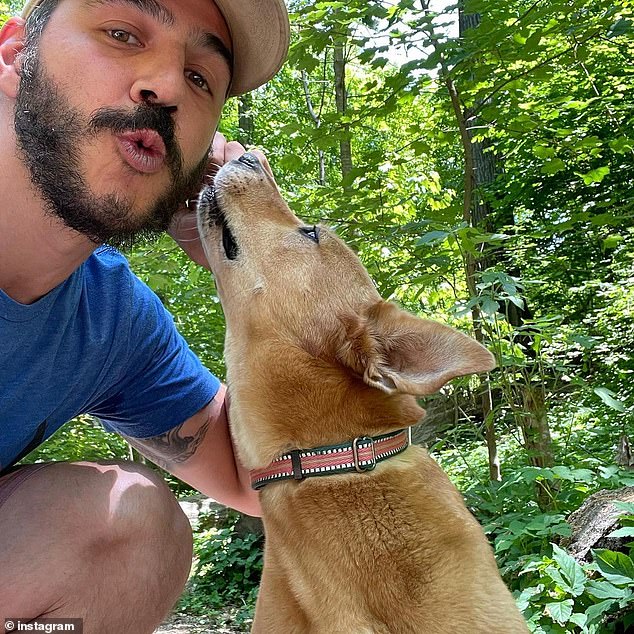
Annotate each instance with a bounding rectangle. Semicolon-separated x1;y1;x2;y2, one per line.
337;301;495;395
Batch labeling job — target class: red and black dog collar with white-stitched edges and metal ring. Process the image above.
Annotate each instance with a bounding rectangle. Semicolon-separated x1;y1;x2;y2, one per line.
250;427;412;490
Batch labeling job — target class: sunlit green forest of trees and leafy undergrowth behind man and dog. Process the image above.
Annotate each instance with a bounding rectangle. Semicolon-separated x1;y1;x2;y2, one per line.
0;0;634;632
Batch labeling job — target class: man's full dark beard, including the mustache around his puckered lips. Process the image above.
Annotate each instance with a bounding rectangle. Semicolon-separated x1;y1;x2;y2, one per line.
15;45;207;247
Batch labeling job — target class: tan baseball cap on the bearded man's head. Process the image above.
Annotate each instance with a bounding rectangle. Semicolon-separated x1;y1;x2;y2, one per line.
22;0;290;97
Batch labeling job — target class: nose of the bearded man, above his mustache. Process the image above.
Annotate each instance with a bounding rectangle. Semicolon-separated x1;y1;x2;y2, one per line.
130;55;186;114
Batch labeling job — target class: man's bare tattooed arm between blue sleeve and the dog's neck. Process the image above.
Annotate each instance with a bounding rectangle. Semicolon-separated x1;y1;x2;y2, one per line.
125;385;262;516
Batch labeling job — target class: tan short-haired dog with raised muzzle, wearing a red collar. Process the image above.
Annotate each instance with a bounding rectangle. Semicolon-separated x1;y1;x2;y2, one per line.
199;154;528;634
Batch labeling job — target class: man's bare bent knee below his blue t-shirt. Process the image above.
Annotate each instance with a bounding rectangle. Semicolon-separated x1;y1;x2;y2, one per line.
0;462;192;632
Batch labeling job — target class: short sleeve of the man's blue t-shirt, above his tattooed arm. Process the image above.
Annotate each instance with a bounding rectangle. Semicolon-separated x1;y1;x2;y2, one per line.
91;276;220;438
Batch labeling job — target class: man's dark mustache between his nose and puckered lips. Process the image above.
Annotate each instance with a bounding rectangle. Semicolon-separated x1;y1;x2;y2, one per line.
89;103;183;175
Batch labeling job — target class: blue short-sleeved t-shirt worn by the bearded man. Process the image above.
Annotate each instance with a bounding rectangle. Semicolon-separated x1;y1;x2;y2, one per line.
0;247;220;471
